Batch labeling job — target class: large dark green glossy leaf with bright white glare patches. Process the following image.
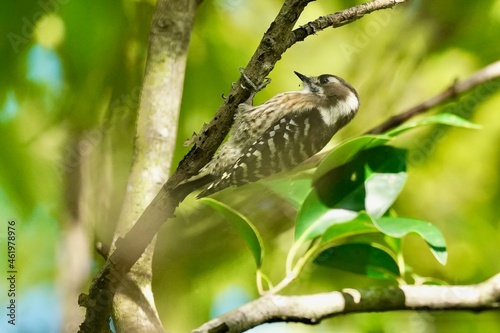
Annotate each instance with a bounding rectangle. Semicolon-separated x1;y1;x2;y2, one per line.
295;146;406;241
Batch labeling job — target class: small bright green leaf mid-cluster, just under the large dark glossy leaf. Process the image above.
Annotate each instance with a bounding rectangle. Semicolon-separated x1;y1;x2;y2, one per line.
320;213;379;245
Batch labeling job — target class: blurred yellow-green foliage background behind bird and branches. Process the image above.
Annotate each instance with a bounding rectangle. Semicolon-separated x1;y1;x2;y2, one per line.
0;0;500;332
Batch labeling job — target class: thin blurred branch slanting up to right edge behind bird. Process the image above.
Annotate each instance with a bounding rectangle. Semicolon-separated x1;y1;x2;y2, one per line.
366;61;500;134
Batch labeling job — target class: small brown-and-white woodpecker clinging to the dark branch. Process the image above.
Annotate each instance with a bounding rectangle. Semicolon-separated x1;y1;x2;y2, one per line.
178;72;359;198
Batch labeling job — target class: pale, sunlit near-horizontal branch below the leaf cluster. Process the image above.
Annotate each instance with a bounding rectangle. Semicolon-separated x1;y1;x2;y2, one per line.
192;274;500;333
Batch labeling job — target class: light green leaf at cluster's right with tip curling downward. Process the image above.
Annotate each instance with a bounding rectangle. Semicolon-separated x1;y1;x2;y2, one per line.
374;217;448;265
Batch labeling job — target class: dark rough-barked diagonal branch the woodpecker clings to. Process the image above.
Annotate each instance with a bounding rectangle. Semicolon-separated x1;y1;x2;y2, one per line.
79;0;407;332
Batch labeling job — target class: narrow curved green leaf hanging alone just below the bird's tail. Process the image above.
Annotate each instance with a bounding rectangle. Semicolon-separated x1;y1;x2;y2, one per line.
200;198;264;268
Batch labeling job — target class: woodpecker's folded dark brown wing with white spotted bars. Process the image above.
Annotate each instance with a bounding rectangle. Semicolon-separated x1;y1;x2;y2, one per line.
197;109;334;198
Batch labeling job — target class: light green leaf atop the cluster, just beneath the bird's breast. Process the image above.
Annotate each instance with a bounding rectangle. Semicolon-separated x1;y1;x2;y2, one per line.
313;135;391;182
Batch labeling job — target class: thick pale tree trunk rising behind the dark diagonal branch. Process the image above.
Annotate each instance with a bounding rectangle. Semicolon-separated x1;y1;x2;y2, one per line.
113;0;200;332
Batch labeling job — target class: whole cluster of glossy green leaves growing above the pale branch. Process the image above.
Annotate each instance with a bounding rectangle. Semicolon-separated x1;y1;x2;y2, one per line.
202;113;478;294
